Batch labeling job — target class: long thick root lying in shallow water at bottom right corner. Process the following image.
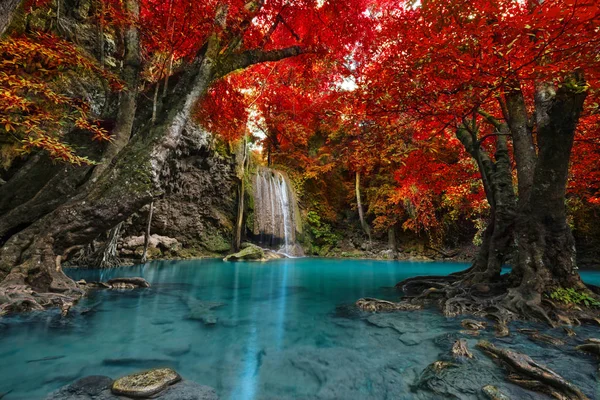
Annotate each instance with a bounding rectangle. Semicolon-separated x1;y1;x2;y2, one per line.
477;341;589;400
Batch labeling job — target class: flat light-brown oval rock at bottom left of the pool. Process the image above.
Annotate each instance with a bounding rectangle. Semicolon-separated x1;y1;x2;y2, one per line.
111;368;181;397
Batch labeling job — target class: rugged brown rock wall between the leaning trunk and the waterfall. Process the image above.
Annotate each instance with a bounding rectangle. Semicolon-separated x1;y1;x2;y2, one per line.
121;124;237;258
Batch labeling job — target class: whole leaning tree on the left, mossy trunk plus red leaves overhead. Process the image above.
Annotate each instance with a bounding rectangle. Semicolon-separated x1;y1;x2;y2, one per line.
0;0;370;310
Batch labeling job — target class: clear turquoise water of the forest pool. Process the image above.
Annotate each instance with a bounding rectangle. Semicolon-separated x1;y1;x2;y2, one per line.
0;259;600;400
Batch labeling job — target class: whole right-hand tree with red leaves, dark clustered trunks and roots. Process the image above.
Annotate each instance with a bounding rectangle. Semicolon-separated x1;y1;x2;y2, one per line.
361;0;600;323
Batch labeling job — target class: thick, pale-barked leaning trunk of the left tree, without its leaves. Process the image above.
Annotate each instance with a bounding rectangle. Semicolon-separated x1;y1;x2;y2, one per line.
0;36;216;300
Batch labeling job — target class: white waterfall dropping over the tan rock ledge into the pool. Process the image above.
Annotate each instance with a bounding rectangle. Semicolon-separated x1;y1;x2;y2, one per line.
253;167;304;256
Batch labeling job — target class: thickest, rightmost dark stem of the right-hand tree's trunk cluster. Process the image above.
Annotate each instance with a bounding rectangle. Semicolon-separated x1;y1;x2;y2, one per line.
514;74;586;302
